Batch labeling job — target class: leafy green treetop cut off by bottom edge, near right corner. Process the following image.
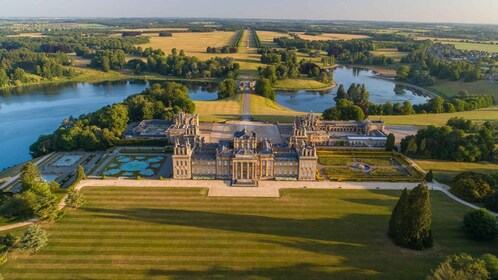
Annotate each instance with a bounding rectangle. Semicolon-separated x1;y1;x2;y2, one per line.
427;254;490;280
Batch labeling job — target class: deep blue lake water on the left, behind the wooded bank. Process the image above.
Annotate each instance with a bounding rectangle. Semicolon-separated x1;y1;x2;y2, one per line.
0;81;217;170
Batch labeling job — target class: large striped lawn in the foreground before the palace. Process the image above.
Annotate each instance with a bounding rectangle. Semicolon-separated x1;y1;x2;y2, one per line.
2;187;498;279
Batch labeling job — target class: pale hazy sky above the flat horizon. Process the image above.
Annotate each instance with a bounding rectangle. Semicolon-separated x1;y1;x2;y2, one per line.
0;0;498;24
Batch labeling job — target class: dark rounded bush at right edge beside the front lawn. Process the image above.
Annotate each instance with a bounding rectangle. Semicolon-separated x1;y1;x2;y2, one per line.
463;209;498;241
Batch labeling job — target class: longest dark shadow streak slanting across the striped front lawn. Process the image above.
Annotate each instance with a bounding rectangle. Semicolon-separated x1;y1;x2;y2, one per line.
83;207;389;243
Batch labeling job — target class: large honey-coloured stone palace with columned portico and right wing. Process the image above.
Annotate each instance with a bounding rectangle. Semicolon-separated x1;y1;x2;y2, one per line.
171;112;386;186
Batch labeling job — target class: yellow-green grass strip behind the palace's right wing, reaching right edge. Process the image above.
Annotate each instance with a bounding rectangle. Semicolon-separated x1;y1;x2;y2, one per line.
369;106;498;126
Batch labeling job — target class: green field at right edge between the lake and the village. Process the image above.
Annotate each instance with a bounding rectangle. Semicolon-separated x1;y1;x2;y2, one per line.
425;80;498;100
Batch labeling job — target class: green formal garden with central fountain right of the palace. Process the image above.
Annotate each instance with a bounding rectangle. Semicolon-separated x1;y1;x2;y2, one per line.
318;150;424;182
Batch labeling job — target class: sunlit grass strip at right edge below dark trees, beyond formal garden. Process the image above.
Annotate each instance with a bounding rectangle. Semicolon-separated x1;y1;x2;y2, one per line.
415;159;498;184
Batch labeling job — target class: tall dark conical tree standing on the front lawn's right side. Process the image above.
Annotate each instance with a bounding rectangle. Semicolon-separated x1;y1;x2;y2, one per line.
389;184;432;250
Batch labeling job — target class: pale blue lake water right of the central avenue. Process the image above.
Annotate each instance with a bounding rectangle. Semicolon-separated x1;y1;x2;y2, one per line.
277;66;429;112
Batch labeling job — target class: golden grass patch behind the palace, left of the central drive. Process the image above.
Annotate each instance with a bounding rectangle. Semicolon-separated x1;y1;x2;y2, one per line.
194;94;242;122
